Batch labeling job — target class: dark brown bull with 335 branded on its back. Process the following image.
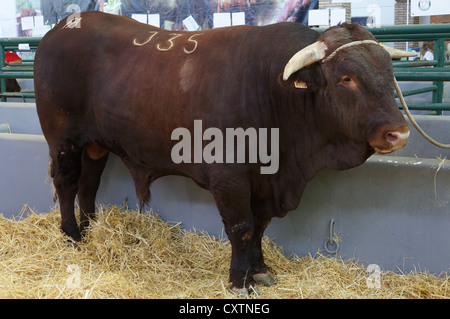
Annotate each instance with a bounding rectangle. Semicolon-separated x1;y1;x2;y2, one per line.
35;12;409;294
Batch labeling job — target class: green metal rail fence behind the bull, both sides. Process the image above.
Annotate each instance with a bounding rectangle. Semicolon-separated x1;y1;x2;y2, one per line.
0;24;450;114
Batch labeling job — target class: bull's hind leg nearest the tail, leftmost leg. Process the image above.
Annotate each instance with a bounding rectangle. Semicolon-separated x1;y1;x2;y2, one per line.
50;144;81;241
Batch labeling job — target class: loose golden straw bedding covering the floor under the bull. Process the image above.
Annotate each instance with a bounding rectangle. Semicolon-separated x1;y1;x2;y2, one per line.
0;207;450;298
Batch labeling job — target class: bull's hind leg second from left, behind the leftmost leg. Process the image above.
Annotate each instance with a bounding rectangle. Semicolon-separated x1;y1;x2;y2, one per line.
78;142;108;236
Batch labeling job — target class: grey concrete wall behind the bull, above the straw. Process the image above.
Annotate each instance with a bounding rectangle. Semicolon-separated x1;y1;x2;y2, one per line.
0;104;450;273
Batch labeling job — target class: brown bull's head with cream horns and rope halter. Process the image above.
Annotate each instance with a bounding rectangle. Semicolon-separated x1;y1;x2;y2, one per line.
283;24;415;158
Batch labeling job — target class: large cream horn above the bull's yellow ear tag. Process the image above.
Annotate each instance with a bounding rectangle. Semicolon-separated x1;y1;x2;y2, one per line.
283;41;327;81
